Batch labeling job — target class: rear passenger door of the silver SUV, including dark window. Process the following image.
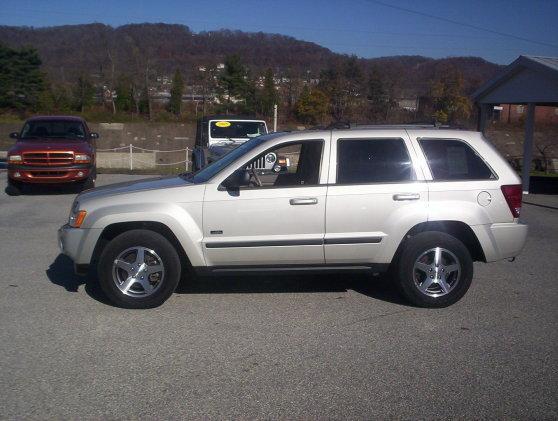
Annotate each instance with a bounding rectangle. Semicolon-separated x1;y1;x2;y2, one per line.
324;129;428;264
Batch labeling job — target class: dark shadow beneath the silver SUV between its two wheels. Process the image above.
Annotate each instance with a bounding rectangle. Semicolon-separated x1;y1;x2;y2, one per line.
175;273;409;305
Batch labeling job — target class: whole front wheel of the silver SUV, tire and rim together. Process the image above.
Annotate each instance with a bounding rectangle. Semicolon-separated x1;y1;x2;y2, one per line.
98;230;180;308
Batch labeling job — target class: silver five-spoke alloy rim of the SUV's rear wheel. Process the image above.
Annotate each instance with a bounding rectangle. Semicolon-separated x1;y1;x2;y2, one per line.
413;247;462;298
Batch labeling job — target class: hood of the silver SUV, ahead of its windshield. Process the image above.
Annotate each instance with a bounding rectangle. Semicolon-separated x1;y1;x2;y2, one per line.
77;176;193;202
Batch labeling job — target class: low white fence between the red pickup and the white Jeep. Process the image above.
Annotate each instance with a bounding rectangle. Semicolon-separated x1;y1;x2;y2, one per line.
97;143;192;171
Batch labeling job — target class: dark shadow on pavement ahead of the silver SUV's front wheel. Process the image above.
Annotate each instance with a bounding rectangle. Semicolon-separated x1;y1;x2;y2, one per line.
46;254;112;305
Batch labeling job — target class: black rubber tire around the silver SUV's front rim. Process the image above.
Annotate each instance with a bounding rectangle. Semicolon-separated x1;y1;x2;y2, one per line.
97;229;181;308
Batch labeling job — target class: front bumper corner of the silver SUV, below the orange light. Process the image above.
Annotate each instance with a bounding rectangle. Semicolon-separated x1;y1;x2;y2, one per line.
58;224;102;265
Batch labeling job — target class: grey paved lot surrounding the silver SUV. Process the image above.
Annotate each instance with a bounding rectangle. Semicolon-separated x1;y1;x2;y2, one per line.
0;173;558;419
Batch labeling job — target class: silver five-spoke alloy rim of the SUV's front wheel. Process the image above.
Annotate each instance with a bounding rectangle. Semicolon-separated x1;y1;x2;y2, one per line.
112;246;165;298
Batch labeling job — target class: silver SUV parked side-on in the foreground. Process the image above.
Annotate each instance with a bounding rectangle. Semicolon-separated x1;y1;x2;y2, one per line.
59;127;527;308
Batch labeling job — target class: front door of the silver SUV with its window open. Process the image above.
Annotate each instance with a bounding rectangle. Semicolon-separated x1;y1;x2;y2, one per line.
202;135;329;266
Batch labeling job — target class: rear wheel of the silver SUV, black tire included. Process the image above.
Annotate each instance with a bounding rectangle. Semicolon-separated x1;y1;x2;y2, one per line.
394;231;473;308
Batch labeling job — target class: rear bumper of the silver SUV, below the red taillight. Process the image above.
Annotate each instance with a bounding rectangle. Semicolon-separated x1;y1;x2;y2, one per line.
471;222;529;262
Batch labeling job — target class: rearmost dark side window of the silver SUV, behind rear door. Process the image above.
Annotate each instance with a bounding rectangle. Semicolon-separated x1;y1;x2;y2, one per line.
419;139;496;180
